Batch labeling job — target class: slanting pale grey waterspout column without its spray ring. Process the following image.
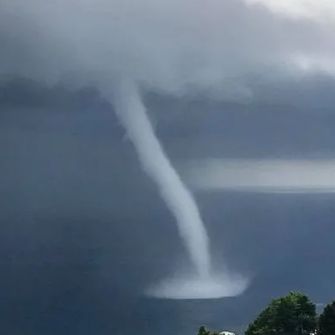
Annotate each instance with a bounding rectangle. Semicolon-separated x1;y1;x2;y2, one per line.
110;80;210;276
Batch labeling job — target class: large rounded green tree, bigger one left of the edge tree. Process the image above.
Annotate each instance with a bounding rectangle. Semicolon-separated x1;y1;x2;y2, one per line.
245;292;316;335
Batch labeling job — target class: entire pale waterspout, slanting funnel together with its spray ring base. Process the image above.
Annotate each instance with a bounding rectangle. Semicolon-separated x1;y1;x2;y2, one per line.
113;80;245;299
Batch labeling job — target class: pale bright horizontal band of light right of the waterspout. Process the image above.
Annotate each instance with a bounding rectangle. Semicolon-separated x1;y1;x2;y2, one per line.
190;159;335;193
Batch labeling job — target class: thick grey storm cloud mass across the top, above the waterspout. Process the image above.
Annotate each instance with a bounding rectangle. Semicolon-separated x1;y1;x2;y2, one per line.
0;0;334;97
